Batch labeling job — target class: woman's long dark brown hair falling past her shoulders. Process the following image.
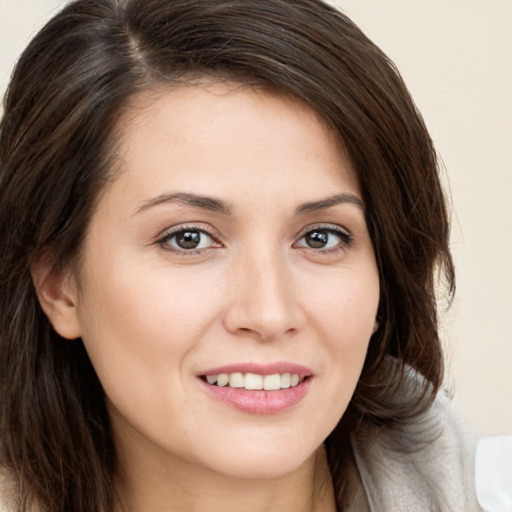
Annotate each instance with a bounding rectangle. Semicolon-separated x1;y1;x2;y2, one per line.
0;0;454;512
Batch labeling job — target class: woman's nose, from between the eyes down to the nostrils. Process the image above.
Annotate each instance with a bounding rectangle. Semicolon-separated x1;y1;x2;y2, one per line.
224;248;300;341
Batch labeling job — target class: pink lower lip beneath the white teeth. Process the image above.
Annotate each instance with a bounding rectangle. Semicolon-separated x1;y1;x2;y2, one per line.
201;377;312;415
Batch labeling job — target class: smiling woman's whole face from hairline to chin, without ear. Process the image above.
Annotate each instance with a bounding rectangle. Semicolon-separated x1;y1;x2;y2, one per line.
68;85;379;477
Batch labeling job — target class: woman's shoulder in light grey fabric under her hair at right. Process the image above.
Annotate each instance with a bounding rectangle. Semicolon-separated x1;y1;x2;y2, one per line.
353;384;482;512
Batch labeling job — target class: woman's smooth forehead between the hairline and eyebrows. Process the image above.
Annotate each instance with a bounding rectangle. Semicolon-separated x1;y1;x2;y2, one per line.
107;83;359;211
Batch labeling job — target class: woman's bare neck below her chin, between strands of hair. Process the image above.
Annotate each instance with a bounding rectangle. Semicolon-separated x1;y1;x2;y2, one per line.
114;446;335;512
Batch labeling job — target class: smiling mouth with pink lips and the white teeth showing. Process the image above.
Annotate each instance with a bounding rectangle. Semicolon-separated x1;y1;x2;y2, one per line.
200;363;313;415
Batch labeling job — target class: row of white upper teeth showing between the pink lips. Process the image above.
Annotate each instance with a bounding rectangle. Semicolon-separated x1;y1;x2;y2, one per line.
206;372;303;391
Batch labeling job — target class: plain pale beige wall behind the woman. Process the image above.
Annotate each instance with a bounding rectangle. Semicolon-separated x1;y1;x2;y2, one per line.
0;0;512;433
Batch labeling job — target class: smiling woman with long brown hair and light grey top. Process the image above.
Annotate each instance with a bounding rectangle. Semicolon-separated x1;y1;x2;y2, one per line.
0;0;496;512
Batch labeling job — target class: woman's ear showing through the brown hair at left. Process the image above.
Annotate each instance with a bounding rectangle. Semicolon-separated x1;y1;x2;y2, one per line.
31;250;82;340
